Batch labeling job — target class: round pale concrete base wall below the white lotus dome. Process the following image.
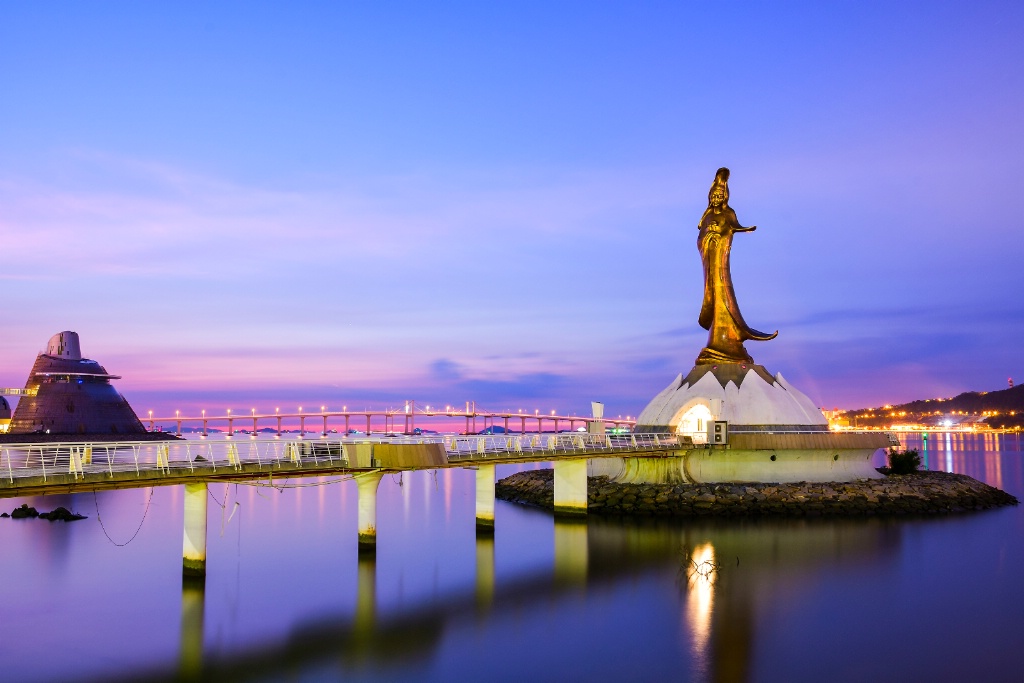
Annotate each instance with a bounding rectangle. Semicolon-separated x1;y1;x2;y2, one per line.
590;449;883;483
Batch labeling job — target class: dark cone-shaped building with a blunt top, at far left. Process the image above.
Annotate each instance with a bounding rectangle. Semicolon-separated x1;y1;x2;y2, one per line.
9;332;145;434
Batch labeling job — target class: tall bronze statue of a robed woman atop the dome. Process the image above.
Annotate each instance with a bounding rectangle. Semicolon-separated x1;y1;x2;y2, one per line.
696;168;778;366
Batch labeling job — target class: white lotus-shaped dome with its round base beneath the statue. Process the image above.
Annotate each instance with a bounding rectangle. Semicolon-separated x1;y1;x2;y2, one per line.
590;364;893;483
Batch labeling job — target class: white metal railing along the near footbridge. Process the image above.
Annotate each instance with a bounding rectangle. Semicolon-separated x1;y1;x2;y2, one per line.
0;432;678;483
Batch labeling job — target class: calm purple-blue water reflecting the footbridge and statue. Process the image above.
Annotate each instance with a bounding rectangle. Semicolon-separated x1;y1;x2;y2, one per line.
0;435;1024;681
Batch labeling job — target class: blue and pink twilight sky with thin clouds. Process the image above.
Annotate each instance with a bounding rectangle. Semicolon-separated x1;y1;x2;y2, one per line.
0;0;1024;415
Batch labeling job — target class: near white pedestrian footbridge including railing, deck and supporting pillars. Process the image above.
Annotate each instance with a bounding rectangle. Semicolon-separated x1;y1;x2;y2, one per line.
0;432;679;575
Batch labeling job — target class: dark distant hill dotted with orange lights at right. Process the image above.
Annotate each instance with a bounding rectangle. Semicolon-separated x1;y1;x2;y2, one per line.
846;384;1024;429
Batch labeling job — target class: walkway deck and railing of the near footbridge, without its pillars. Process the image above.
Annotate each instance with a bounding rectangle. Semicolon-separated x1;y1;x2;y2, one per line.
0;433;680;498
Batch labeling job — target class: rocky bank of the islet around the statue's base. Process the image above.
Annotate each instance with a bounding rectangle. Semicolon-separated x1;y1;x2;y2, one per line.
495;470;1018;517
